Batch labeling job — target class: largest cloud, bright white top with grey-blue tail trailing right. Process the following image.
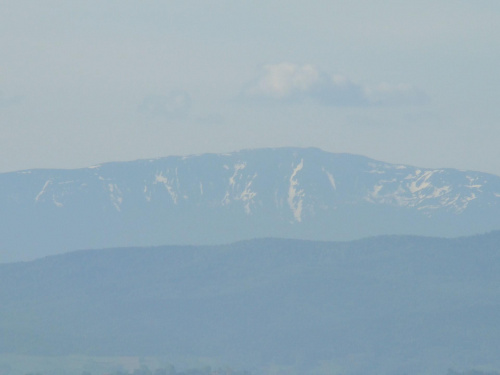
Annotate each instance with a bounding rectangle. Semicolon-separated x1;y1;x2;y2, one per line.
244;63;428;107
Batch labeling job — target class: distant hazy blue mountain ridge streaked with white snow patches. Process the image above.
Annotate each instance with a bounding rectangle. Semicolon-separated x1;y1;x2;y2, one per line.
0;148;500;262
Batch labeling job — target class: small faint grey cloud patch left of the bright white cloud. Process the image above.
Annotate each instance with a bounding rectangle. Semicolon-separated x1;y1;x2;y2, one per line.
138;91;191;119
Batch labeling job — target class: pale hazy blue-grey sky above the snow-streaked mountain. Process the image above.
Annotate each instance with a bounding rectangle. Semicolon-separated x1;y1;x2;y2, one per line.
0;0;500;175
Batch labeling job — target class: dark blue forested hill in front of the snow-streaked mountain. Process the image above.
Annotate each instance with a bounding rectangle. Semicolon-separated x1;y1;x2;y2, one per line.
0;232;500;374
